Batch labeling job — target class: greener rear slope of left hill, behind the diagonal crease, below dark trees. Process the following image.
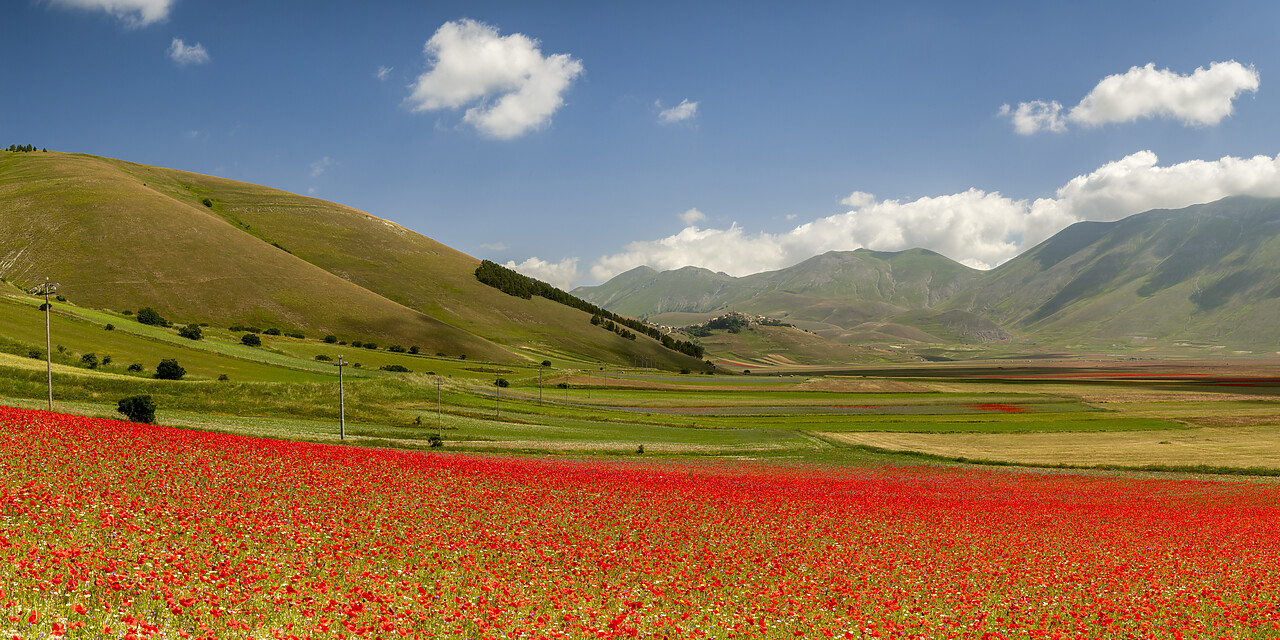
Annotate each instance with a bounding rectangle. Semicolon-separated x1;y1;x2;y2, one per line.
115;152;694;367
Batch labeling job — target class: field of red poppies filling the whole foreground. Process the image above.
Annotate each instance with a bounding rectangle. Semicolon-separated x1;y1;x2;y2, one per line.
0;407;1280;639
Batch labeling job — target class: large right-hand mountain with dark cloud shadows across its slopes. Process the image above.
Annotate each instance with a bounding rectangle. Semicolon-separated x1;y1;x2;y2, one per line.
947;197;1280;351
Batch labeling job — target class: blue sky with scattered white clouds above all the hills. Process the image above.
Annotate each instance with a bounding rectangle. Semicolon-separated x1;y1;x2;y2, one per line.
0;0;1280;287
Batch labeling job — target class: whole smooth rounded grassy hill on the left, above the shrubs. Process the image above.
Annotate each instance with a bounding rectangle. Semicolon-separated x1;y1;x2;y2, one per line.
0;152;696;367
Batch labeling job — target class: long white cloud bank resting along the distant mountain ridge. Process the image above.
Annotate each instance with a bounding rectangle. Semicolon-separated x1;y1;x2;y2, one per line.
590;151;1280;282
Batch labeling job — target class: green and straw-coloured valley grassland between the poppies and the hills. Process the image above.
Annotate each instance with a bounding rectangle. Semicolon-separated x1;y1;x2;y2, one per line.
0;282;1280;468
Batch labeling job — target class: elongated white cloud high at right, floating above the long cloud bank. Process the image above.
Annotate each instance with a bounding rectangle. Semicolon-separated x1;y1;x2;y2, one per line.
1000;60;1261;136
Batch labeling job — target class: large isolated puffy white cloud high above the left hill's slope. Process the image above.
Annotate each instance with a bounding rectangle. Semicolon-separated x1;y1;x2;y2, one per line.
406;19;582;140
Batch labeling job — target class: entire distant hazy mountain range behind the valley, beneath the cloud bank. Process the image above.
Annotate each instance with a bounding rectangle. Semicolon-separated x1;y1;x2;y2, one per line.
575;197;1280;351
